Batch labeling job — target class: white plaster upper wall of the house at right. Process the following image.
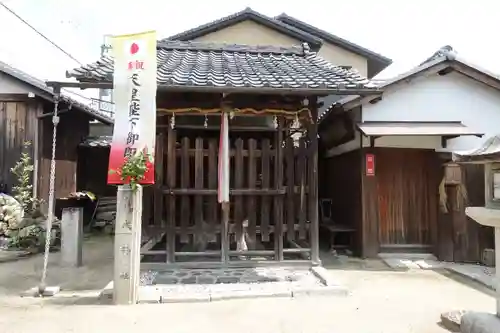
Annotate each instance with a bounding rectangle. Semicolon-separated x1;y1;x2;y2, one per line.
328;72;500;156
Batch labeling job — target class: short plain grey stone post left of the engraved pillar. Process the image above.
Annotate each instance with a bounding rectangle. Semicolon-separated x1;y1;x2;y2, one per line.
61;207;83;267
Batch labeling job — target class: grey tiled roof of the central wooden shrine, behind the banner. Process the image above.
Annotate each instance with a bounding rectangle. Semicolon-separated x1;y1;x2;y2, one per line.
67;41;376;93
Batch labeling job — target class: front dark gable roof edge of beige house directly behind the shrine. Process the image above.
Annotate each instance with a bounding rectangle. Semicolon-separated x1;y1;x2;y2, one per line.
163;7;322;51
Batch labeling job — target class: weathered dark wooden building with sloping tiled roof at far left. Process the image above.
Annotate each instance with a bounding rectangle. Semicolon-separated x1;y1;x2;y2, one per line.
0;62;113;205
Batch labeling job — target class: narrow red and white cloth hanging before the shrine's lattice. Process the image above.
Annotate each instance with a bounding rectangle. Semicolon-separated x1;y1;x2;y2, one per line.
218;112;229;203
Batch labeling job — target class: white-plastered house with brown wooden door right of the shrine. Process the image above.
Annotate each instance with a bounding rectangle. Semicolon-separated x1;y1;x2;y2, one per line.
320;46;500;261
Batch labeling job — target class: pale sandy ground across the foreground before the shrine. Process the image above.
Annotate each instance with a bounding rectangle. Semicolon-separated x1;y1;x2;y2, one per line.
0;235;495;333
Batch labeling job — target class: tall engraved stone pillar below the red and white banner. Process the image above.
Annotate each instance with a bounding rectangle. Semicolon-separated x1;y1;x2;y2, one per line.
113;185;142;304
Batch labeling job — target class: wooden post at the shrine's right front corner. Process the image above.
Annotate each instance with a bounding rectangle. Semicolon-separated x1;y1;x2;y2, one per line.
308;97;321;265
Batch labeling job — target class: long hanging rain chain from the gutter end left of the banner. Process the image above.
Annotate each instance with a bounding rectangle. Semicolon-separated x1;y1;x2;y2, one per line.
38;93;60;295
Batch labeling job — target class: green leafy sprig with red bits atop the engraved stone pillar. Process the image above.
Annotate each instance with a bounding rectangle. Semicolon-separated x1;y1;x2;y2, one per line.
109;151;153;191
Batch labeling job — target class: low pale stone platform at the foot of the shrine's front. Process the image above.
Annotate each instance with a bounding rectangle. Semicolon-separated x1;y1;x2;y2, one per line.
99;267;349;303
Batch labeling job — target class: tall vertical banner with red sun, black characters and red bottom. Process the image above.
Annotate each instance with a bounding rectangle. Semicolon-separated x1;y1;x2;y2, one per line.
108;31;156;184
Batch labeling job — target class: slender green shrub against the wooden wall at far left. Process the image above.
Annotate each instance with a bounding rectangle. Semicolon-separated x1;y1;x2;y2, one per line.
10;141;43;216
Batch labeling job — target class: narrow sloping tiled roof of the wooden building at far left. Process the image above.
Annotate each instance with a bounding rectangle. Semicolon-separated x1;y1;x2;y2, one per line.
0;61;114;125
